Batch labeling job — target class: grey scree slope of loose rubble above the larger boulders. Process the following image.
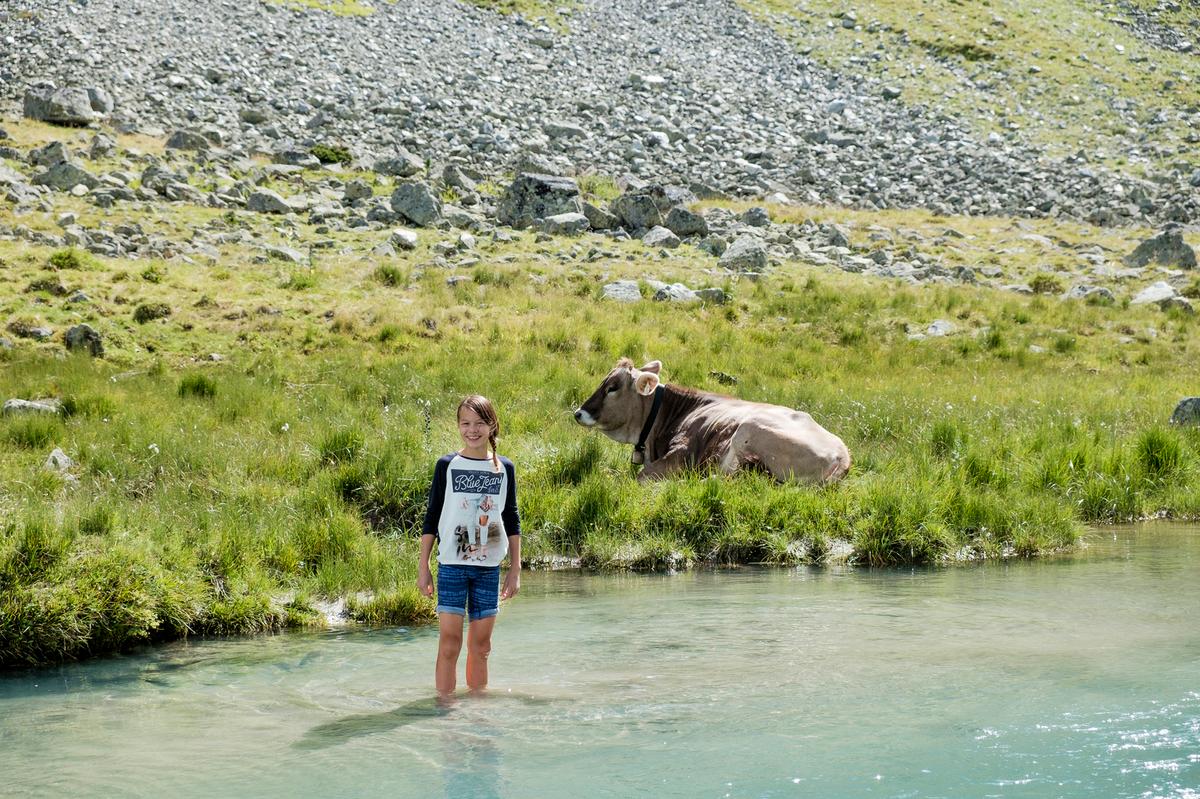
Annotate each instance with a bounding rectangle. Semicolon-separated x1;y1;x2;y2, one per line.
7;0;1200;224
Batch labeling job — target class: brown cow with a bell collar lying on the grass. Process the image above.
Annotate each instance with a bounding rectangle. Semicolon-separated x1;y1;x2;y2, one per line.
575;358;850;482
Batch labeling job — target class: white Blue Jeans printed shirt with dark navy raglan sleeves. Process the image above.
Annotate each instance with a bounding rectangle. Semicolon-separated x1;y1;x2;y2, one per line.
421;452;521;566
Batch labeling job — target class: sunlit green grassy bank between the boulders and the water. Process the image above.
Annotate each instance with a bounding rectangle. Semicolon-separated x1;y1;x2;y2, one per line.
0;221;1200;663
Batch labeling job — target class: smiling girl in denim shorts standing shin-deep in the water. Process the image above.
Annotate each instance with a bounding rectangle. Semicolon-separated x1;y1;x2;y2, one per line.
416;395;521;696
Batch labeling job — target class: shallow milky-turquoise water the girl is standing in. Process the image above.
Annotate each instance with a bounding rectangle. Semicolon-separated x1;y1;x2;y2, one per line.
0;523;1200;799
